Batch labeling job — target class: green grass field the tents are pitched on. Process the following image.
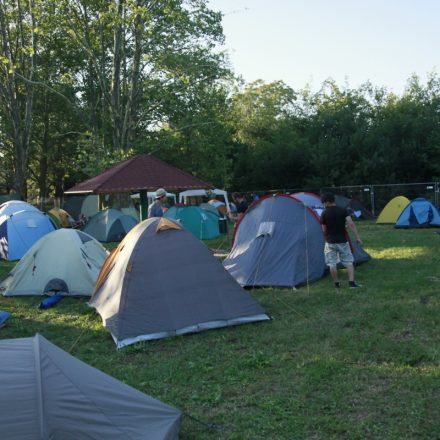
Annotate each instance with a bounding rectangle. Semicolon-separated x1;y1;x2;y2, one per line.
0;222;440;440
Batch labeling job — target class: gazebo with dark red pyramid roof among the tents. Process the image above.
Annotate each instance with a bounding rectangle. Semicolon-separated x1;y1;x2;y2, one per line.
64;154;213;220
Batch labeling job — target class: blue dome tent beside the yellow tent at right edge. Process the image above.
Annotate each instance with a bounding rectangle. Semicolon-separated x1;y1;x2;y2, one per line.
394;197;440;228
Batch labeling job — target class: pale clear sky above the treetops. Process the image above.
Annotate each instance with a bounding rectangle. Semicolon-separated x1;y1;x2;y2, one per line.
208;0;440;94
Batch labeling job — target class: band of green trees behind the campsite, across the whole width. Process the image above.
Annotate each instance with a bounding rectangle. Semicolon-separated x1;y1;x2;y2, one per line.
0;0;440;198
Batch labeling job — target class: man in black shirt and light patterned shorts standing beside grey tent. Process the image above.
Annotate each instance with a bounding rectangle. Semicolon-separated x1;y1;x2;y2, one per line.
321;194;362;288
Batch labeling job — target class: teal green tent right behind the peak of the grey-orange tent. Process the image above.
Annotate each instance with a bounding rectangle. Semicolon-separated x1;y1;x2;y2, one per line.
164;205;220;240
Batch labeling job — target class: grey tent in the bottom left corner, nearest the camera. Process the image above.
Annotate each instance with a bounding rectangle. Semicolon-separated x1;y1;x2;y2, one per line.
0;334;181;440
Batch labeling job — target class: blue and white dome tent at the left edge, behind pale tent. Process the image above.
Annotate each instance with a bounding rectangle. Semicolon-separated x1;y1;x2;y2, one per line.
0;211;56;260
